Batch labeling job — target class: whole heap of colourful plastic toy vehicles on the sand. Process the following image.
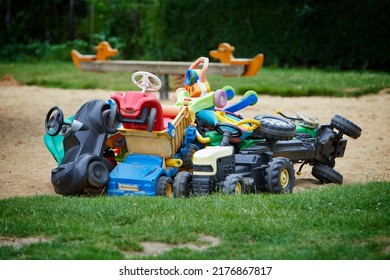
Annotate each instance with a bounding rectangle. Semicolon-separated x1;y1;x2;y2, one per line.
44;57;361;197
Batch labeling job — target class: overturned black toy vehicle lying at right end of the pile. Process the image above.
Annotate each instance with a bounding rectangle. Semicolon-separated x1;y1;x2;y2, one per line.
247;111;362;184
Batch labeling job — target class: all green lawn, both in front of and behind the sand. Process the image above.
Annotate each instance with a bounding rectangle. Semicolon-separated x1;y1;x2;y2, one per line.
0;62;390;260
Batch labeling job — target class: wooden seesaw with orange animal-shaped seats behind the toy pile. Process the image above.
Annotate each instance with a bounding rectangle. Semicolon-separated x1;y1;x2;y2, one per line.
71;42;263;99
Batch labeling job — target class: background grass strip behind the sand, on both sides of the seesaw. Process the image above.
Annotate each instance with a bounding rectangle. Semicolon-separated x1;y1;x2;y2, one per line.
0;62;390;96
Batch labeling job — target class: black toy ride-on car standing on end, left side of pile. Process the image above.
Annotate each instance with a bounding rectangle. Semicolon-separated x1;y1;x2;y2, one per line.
45;99;117;195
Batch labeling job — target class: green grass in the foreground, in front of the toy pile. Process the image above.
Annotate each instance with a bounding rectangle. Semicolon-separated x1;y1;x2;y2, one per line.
0;182;390;259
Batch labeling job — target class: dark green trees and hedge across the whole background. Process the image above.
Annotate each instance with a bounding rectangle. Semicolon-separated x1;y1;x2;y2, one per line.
0;0;390;71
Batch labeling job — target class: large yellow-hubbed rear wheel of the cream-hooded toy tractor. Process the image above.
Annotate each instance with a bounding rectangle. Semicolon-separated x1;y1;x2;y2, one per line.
264;157;295;193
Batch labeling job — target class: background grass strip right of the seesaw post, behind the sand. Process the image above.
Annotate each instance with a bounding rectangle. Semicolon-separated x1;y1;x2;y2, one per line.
209;68;390;97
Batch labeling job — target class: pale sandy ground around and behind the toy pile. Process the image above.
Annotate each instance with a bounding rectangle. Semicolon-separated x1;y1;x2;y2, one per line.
0;76;390;198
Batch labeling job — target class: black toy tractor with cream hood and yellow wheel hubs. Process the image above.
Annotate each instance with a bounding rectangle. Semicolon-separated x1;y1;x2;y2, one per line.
173;123;295;196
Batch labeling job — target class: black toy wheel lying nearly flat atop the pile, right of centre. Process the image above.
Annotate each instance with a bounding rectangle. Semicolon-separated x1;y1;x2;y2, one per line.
254;115;296;142
